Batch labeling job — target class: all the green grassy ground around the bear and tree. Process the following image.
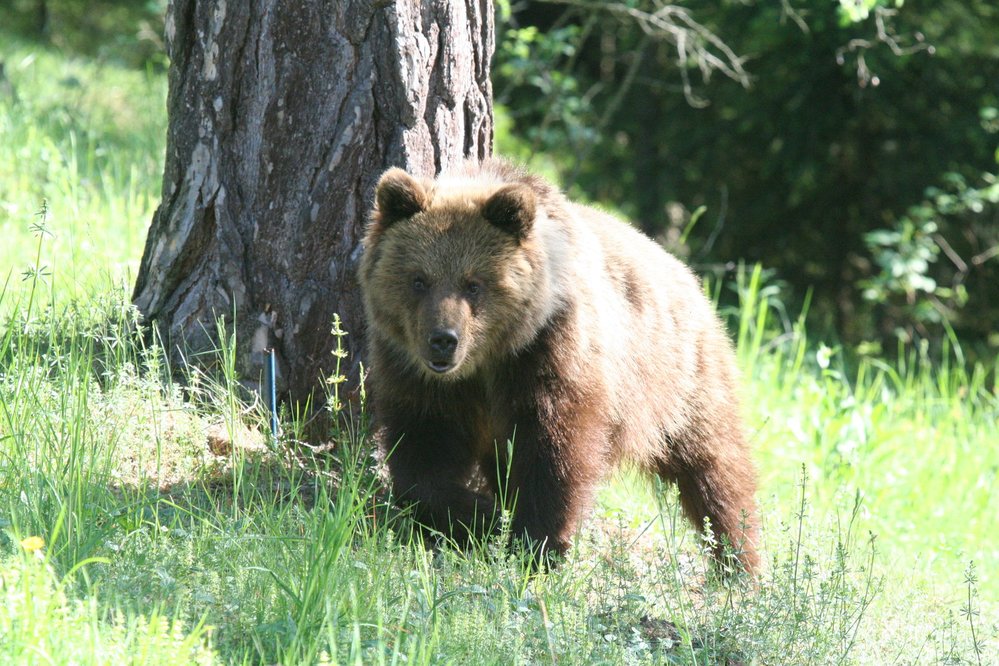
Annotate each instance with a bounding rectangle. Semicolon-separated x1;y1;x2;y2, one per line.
0;39;999;664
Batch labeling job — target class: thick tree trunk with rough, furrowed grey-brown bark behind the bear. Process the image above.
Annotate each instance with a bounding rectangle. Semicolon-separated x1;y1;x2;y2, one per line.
133;0;493;398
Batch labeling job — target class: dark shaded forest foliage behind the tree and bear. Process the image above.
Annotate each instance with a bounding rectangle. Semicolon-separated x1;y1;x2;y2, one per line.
0;0;999;365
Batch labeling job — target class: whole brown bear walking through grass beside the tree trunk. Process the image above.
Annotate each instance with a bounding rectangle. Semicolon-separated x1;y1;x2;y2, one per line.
359;159;758;571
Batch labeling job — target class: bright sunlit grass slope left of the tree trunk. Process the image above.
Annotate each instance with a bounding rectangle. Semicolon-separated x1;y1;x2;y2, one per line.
0;33;166;303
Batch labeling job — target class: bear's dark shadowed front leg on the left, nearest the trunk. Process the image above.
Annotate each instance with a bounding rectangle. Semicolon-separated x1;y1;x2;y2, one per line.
383;418;498;546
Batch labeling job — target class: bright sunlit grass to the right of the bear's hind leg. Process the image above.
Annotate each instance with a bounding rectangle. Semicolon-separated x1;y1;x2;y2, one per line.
728;266;999;594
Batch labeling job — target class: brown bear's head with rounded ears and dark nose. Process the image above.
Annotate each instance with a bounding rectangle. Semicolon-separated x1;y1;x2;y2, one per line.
359;169;550;381
